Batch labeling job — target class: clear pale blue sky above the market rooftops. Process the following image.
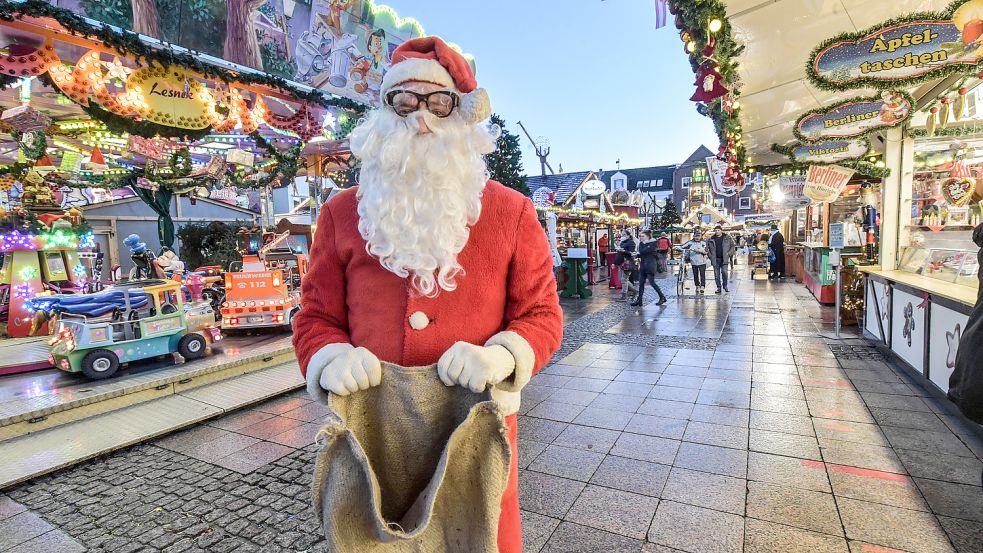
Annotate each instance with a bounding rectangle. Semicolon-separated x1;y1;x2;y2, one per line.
380;0;717;174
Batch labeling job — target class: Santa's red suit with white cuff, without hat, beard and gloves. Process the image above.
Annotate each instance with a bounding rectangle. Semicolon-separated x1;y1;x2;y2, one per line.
293;181;563;552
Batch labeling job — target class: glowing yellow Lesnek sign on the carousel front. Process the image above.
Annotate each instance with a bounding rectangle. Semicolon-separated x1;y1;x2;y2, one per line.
126;67;209;130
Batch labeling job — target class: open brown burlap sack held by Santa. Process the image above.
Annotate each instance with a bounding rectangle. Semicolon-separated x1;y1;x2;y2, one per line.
313;364;511;553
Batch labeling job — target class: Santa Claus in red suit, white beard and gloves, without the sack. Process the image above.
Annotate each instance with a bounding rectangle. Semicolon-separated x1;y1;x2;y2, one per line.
293;37;563;553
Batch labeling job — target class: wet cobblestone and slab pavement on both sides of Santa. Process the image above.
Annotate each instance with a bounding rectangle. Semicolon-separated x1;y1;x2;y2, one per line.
0;266;983;553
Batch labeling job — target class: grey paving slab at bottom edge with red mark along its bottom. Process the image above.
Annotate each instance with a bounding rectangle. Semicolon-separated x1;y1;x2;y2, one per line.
836;498;954;553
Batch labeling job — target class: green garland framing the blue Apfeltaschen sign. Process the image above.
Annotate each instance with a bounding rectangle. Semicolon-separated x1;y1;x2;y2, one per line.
806;0;983;90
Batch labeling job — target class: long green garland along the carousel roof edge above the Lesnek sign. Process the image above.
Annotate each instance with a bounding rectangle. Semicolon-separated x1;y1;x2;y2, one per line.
0;0;365;111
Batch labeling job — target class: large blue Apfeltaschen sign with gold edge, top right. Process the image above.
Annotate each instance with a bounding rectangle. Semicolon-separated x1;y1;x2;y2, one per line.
810;0;983;89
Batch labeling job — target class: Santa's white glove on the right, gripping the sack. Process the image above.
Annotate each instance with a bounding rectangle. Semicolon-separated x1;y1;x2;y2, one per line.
437;342;515;393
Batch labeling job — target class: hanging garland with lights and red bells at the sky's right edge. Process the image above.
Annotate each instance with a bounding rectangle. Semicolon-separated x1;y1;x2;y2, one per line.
669;0;747;165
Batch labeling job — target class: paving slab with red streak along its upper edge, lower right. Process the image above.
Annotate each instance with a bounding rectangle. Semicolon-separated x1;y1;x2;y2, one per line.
827;465;936;511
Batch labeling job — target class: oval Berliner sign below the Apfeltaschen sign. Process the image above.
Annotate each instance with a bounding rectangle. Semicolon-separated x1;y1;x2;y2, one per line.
794;90;911;142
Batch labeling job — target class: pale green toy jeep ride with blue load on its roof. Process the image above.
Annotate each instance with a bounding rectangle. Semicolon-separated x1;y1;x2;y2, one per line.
48;280;222;379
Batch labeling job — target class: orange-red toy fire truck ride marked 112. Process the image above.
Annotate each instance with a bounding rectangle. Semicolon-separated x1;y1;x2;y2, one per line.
222;234;307;330
